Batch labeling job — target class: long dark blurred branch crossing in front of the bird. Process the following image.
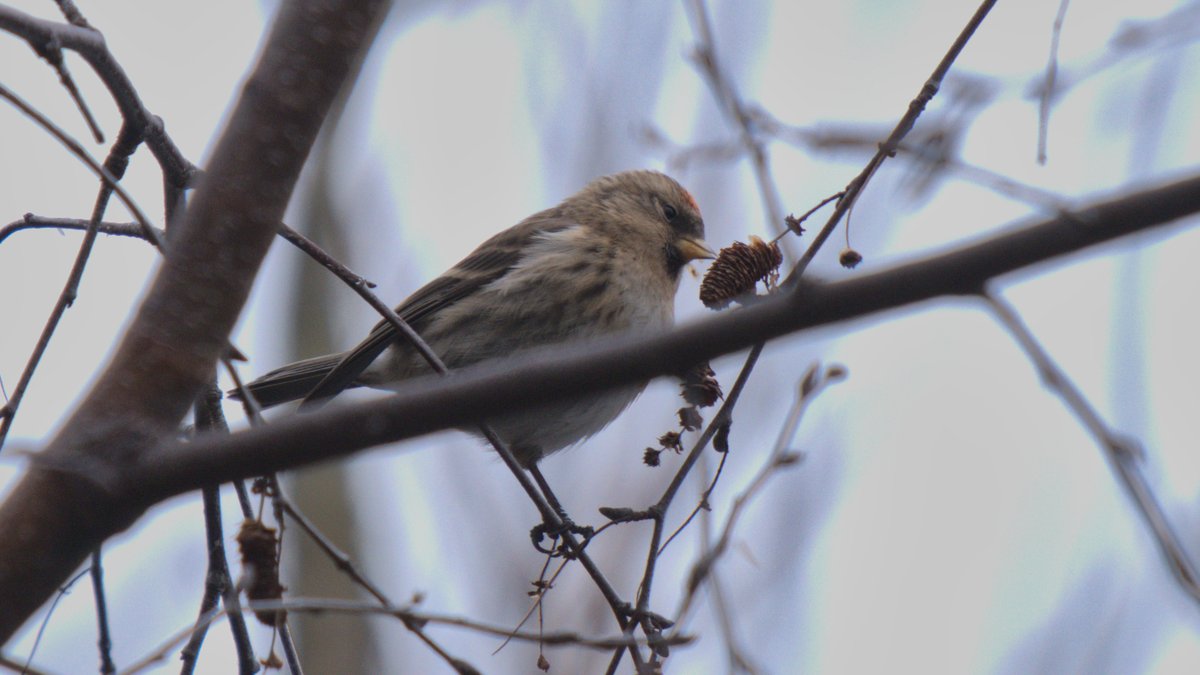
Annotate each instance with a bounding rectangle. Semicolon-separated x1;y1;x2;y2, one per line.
129;175;1200;501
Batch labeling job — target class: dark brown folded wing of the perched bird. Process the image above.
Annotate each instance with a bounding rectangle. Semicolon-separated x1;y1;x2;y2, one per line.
301;211;571;407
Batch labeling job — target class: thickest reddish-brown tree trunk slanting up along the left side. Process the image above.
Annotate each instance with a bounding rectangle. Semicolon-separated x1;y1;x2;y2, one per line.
0;0;383;641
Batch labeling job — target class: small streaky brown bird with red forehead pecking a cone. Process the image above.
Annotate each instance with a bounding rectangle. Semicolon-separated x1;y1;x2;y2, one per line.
230;171;713;467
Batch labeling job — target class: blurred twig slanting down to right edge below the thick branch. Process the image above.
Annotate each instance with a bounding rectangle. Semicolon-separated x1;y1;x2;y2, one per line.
983;291;1200;602
